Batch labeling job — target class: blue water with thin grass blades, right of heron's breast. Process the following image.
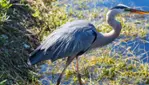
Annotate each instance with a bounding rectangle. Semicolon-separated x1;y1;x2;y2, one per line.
111;35;149;63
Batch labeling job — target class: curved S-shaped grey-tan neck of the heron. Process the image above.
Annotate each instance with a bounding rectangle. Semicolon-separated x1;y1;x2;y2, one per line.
92;11;122;48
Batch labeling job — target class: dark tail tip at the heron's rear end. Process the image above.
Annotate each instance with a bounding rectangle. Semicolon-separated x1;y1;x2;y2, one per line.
27;50;44;65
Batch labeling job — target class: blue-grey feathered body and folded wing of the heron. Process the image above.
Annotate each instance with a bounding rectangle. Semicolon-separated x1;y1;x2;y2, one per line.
29;20;96;64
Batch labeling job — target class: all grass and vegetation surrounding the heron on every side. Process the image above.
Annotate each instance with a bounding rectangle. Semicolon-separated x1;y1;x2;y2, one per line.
0;0;149;85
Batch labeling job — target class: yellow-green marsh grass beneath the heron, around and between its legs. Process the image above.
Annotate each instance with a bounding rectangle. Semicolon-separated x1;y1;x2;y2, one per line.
38;50;149;85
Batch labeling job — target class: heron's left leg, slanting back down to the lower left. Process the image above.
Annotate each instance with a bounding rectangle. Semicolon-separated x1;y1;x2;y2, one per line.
56;56;75;85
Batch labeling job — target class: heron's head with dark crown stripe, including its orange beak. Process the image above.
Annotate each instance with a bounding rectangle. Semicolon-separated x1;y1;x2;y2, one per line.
111;4;149;14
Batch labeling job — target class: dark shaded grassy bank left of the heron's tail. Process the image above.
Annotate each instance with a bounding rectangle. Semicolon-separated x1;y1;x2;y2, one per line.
0;0;38;85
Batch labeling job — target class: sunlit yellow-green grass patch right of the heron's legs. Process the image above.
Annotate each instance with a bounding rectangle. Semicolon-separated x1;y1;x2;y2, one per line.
73;56;149;85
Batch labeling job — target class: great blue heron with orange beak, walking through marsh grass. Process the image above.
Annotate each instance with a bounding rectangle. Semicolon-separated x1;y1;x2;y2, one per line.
28;5;149;85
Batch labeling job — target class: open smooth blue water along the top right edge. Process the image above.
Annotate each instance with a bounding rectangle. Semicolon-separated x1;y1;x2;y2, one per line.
58;0;149;11
